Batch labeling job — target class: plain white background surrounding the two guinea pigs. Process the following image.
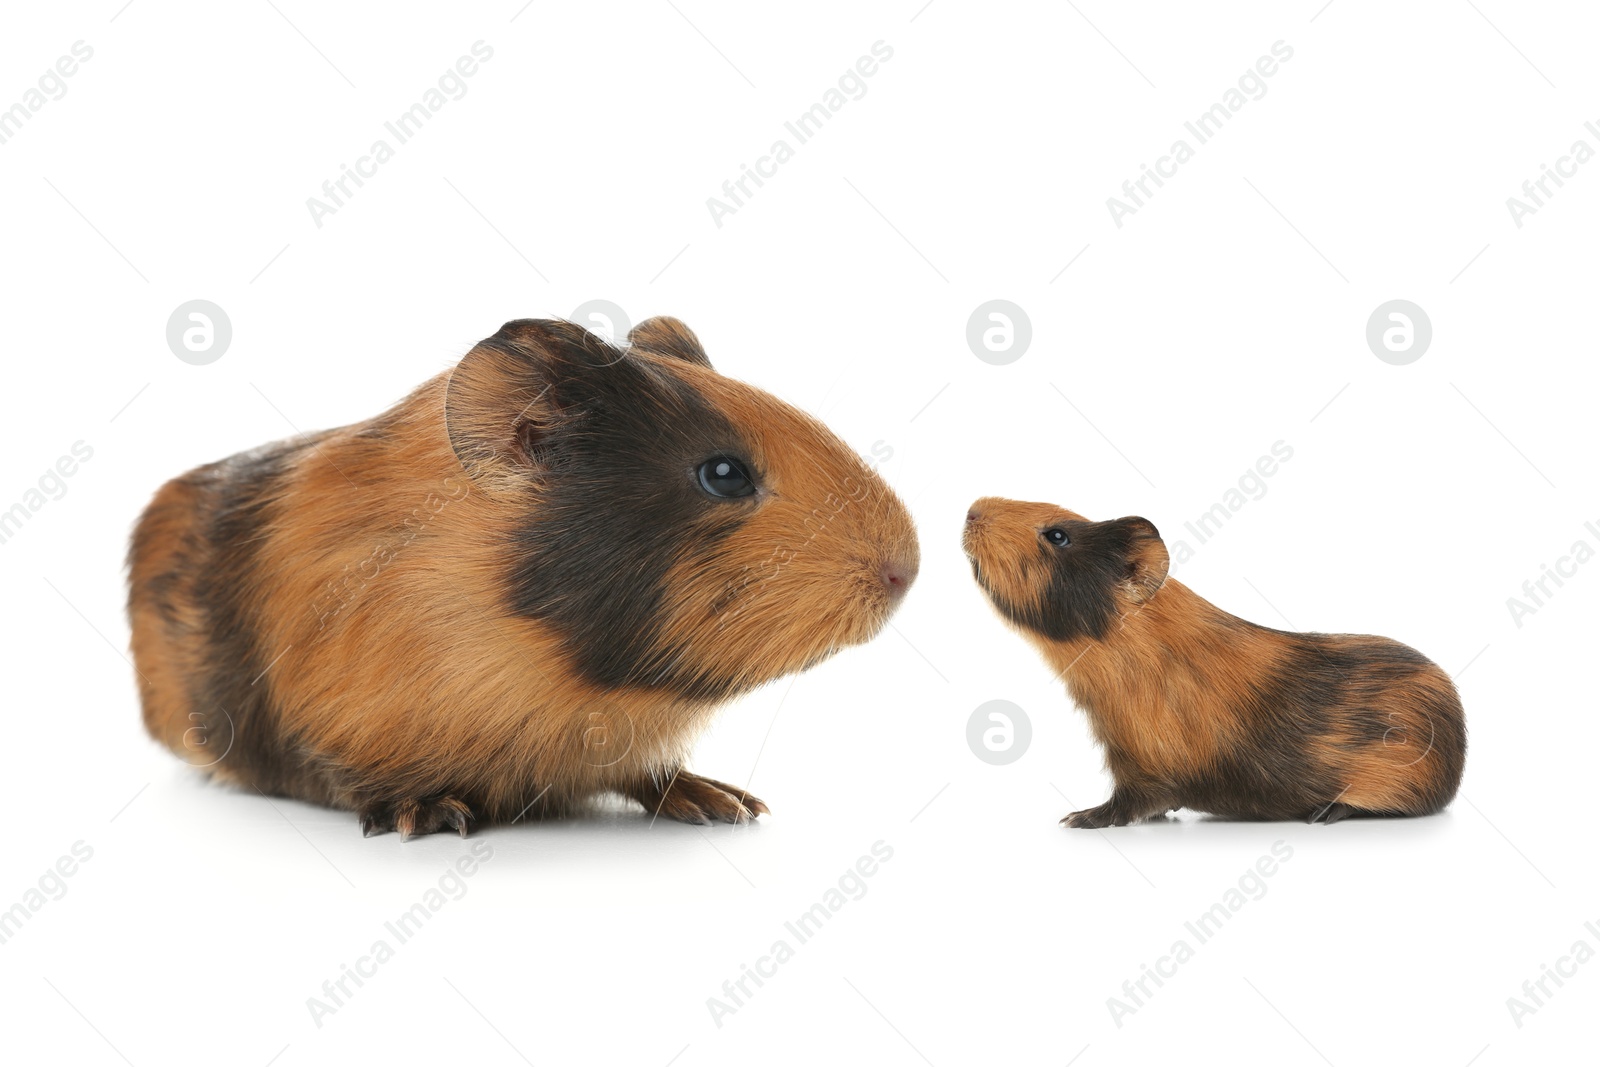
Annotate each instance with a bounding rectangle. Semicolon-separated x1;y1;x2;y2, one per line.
0;0;1600;1067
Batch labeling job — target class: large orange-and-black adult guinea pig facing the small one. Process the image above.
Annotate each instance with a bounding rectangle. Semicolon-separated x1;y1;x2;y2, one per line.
128;318;918;837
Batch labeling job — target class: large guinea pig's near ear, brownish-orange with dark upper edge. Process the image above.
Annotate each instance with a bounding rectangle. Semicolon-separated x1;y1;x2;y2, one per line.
445;318;626;488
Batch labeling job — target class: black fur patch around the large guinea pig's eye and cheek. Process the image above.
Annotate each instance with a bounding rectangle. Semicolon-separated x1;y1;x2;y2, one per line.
510;334;760;701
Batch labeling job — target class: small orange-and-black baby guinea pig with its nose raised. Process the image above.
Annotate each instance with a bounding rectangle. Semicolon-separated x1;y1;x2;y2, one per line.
962;498;1467;827
